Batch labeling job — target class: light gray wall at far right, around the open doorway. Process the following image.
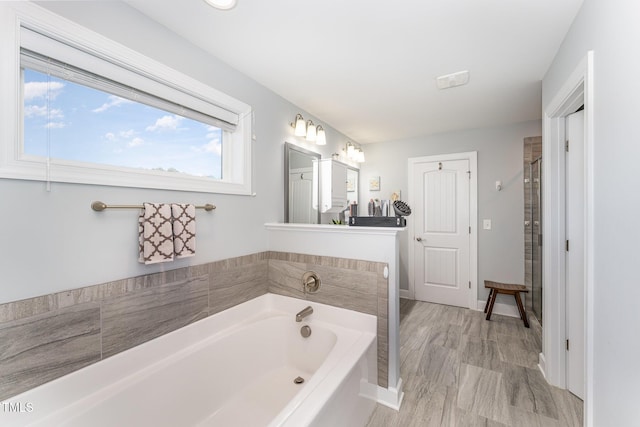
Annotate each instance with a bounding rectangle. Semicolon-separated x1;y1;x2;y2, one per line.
543;0;640;426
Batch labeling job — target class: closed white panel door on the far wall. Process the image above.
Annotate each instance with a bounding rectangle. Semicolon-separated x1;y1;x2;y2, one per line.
411;159;470;307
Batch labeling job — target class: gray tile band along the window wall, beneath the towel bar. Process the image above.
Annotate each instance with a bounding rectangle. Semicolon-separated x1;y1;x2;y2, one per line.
0;252;268;401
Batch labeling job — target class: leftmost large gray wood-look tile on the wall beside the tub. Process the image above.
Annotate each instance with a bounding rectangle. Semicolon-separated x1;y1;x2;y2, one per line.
0;303;100;400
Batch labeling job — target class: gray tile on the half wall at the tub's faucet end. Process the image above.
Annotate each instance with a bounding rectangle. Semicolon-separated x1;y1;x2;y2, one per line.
269;251;389;388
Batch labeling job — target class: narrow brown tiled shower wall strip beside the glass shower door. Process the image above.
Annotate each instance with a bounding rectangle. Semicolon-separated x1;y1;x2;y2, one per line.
523;136;542;311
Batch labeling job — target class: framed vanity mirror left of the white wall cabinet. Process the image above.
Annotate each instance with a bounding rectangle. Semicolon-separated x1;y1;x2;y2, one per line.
284;142;321;224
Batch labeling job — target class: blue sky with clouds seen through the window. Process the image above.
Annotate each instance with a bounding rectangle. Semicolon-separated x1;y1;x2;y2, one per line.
24;69;222;179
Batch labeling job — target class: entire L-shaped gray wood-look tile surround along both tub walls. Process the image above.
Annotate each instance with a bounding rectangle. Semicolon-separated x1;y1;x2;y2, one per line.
0;252;388;401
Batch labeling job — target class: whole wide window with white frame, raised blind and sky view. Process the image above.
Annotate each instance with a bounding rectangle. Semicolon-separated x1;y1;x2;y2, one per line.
0;4;252;194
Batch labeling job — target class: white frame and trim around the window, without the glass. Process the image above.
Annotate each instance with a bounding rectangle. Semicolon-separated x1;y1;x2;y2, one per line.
0;2;253;195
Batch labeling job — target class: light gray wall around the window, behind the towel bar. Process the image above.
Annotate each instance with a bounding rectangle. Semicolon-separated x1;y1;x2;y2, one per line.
0;2;346;303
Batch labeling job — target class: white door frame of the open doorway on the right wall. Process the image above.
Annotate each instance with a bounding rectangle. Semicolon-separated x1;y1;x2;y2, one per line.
539;51;595;426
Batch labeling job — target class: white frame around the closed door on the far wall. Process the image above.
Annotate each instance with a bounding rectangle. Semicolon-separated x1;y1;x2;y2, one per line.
405;151;478;310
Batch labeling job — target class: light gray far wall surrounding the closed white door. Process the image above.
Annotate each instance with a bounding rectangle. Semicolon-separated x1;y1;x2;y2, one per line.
359;121;542;305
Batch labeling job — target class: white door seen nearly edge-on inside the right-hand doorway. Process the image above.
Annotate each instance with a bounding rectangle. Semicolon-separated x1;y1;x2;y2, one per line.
565;111;585;399
